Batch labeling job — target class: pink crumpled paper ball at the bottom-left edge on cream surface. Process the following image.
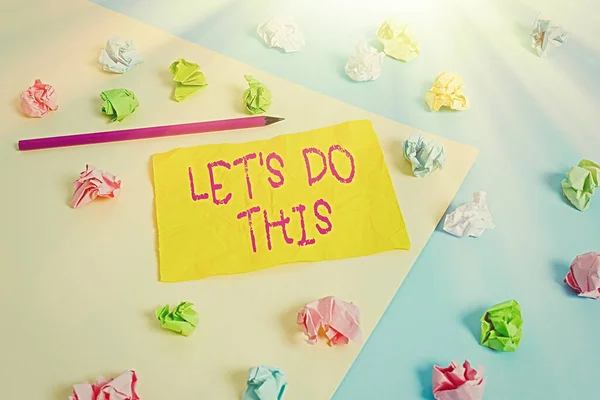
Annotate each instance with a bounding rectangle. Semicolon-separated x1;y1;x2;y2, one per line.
69;370;140;400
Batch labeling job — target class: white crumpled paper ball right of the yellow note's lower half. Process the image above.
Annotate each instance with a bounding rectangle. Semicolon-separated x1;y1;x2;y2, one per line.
444;192;496;237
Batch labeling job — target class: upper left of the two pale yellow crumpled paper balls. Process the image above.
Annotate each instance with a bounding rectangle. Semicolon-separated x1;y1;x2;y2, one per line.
377;18;421;61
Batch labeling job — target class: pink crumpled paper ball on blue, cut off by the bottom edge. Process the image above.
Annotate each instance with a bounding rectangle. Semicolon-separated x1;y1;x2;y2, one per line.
433;361;485;400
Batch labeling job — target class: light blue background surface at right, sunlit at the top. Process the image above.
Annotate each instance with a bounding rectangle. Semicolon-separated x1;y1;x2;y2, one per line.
90;0;600;400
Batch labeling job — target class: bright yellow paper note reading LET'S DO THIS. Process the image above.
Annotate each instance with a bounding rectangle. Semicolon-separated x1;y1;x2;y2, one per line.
152;120;410;282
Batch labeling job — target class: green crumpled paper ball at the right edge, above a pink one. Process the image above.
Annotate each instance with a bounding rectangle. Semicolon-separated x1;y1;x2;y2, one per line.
561;160;600;211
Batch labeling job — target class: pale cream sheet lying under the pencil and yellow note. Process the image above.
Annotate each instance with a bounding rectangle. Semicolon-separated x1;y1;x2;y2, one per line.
0;0;476;400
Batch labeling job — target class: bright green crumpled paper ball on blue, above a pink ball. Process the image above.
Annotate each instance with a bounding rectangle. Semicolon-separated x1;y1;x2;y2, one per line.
481;300;523;351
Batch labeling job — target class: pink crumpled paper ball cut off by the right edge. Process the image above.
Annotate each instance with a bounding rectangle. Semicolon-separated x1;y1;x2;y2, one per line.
565;252;600;299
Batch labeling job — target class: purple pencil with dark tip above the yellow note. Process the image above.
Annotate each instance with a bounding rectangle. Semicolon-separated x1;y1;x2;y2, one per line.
18;116;283;151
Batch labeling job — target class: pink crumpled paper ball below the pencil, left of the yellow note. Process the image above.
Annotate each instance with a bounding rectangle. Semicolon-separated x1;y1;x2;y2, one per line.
71;165;121;208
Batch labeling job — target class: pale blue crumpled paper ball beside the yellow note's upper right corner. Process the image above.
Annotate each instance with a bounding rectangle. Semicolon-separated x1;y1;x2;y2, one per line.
402;133;446;178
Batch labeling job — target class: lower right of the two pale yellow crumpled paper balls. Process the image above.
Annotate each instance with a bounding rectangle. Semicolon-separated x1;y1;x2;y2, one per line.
425;72;469;111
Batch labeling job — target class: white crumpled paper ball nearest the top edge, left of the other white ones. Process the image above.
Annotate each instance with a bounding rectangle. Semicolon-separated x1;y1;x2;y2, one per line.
256;17;305;53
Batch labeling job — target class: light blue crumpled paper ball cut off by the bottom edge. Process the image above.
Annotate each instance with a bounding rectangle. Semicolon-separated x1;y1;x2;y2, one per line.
242;365;287;400
